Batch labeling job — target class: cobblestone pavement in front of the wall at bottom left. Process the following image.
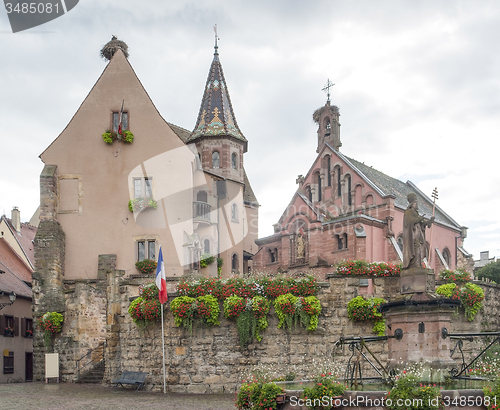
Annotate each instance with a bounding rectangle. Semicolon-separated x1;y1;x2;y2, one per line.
0;382;236;410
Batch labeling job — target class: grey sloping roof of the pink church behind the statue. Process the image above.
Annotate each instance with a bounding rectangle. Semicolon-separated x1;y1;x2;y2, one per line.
344;156;461;229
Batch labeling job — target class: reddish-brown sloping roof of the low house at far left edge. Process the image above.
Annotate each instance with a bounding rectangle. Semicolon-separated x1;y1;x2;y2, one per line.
0;238;32;298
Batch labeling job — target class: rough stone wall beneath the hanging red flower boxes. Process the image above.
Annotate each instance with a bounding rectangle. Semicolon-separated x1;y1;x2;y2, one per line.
35;270;500;393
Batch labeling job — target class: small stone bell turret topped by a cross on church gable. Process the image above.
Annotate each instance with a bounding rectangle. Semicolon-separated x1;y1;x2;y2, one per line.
313;80;342;153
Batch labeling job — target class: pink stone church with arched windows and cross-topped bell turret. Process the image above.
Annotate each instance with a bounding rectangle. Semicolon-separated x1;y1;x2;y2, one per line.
253;94;472;275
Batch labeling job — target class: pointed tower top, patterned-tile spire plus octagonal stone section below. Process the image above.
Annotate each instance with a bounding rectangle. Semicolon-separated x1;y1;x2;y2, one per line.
187;36;248;183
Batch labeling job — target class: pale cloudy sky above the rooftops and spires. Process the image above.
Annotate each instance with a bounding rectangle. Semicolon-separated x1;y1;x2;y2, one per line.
0;0;500;259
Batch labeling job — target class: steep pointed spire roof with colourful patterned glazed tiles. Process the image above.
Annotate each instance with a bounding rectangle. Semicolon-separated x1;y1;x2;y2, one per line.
187;47;247;142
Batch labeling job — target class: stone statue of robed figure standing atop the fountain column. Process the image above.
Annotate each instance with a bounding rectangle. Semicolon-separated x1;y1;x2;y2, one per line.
403;193;434;269
